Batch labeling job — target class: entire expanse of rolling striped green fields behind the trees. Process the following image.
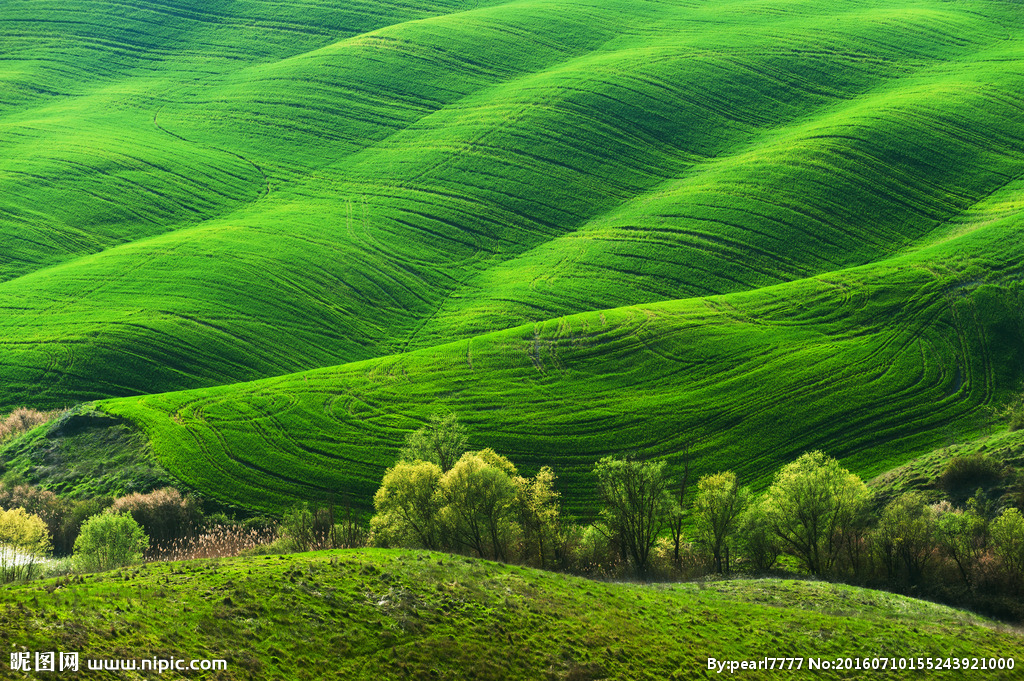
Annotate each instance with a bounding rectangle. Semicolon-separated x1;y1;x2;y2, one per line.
6;0;1024;512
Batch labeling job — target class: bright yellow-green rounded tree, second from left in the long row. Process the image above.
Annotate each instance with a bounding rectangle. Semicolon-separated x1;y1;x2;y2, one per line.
438;450;518;560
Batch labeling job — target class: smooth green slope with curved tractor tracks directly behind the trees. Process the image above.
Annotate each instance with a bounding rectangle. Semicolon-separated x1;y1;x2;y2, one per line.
102;186;1024;511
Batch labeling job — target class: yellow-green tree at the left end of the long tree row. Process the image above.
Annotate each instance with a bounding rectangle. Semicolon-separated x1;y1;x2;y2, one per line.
370;460;442;549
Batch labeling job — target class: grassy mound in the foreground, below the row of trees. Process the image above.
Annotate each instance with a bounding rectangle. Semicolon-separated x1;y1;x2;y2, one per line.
0;550;1020;679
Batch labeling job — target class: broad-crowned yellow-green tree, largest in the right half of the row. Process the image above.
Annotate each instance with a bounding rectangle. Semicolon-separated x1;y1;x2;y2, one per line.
764;452;869;576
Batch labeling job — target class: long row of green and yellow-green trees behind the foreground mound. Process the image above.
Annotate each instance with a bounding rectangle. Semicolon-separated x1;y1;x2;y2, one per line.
371;416;1024;614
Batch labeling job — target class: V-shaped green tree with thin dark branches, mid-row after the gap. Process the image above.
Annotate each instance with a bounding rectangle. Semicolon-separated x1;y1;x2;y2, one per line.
594;457;672;579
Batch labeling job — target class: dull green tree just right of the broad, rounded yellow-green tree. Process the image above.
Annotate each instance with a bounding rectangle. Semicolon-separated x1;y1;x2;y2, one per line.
870;493;938;584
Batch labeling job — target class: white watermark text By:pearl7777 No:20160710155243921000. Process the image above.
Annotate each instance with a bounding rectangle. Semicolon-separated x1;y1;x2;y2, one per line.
708;657;1016;674
